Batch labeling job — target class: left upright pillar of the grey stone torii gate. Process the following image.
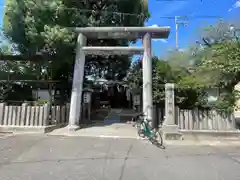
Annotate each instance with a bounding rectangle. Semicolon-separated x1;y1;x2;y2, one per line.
68;34;86;130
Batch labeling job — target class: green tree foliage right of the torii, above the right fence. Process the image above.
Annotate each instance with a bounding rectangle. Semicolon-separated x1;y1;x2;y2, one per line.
128;22;240;111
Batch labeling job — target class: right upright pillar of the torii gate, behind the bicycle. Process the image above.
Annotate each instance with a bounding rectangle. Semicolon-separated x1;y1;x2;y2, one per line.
142;33;153;120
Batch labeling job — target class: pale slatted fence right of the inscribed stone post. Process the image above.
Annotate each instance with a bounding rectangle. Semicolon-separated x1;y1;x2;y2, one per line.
175;109;236;131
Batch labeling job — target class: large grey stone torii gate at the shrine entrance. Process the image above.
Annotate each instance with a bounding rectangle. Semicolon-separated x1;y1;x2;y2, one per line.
68;27;170;130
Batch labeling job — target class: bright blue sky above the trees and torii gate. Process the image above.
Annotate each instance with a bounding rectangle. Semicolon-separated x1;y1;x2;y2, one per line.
0;0;240;56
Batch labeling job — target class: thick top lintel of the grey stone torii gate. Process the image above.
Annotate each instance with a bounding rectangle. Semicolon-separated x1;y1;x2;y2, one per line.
73;26;170;39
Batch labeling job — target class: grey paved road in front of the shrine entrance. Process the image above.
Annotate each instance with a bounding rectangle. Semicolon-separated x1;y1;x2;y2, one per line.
0;135;240;180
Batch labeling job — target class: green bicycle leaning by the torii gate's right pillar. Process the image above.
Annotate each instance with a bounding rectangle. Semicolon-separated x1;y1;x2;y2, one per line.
136;113;163;147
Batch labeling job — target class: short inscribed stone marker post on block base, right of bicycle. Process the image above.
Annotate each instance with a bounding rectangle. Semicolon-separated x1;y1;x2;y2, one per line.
162;83;181;139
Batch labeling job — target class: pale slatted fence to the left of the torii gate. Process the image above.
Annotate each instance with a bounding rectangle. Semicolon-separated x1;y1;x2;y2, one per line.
0;103;69;126
